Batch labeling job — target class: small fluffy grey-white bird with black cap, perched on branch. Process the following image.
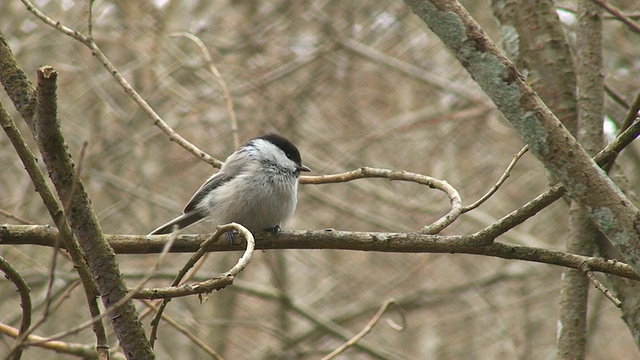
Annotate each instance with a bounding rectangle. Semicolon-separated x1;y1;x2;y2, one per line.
149;133;311;235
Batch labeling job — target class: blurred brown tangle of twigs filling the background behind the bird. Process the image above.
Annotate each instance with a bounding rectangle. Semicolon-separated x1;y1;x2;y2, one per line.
0;0;640;359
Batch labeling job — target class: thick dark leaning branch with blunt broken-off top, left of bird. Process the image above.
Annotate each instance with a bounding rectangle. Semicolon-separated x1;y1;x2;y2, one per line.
34;66;153;359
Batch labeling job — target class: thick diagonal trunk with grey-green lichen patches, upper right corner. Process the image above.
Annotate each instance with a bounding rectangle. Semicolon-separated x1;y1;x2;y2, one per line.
405;0;640;272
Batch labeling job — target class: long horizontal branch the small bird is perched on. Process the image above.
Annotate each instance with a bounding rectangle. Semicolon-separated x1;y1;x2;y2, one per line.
0;225;640;280
